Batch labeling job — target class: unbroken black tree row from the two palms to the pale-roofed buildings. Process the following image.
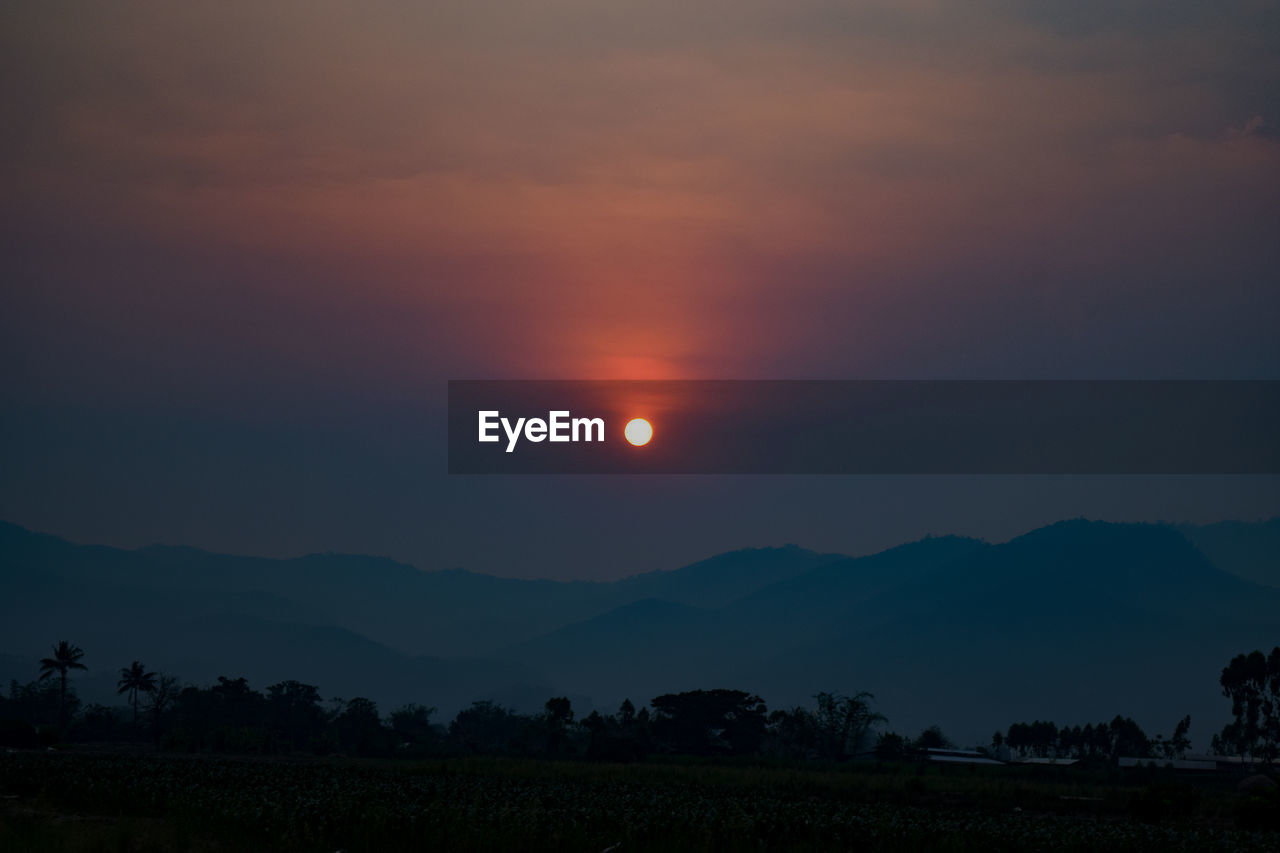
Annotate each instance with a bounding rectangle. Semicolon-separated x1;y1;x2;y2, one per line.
0;643;883;761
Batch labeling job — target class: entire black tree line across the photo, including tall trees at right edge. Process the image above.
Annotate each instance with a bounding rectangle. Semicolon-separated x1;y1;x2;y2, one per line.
0;640;1280;761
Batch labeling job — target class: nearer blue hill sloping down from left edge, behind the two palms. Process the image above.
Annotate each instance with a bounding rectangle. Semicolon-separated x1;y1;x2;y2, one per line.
0;529;530;706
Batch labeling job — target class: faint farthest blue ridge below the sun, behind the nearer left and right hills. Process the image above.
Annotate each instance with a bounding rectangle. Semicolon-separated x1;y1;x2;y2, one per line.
0;524;838;656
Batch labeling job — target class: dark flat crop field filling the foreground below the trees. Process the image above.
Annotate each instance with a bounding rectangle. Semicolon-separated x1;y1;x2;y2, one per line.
0;752;1280;853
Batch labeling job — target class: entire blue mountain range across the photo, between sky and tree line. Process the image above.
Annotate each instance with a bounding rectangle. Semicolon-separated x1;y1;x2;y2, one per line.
0;520;1280;736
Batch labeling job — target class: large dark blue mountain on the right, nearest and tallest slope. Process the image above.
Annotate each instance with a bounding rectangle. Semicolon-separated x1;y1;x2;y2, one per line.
508;521;1280;738
